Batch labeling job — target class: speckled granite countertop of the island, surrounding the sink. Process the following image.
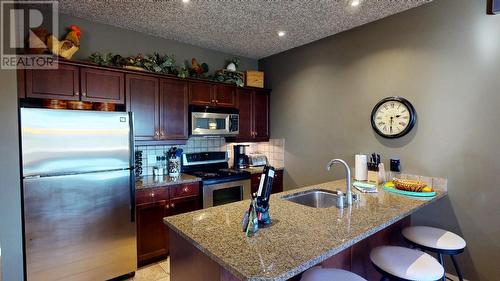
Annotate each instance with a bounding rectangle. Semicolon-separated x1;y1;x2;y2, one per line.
164;180;447;281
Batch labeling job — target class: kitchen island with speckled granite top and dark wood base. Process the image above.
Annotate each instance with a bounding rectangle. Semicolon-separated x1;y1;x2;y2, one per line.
164;180;447;281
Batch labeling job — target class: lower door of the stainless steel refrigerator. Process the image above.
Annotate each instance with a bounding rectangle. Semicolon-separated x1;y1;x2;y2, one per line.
23;170;137;281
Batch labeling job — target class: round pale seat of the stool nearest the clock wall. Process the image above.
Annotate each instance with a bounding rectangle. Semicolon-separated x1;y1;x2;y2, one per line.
401;226;466;251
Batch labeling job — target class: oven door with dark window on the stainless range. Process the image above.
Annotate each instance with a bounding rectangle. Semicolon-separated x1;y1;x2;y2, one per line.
203;180;251;208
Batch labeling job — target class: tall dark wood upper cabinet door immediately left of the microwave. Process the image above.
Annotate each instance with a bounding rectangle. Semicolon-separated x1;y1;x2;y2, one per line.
160;79;189;140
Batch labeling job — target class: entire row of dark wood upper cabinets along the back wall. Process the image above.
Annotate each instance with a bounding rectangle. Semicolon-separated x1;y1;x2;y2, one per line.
17;60;270;144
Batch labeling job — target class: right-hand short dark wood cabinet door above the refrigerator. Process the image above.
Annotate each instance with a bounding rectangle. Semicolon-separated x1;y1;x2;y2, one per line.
80;67;125;104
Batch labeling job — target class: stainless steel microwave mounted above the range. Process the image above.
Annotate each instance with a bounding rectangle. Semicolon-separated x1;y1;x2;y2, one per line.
189;106;240;136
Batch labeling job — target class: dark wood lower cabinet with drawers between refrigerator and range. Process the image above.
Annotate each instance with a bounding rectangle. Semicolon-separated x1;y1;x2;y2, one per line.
136;183;201;266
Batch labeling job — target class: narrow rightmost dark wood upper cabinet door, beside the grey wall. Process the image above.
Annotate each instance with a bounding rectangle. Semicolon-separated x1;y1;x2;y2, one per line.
253;90;270;141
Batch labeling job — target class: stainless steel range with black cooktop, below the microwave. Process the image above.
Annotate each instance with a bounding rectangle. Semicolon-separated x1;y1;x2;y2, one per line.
182;152;251;208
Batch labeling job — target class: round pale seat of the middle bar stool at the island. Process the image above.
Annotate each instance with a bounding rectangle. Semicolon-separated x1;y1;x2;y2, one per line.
370;246;444;281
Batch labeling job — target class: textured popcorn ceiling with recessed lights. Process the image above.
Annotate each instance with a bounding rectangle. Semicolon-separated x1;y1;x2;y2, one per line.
59;0;430;59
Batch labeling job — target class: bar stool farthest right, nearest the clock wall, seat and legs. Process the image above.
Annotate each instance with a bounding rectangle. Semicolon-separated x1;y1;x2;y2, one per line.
402;226;467;281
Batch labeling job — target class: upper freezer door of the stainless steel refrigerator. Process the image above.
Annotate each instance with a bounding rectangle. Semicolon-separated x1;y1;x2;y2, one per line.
21;108;131;177
